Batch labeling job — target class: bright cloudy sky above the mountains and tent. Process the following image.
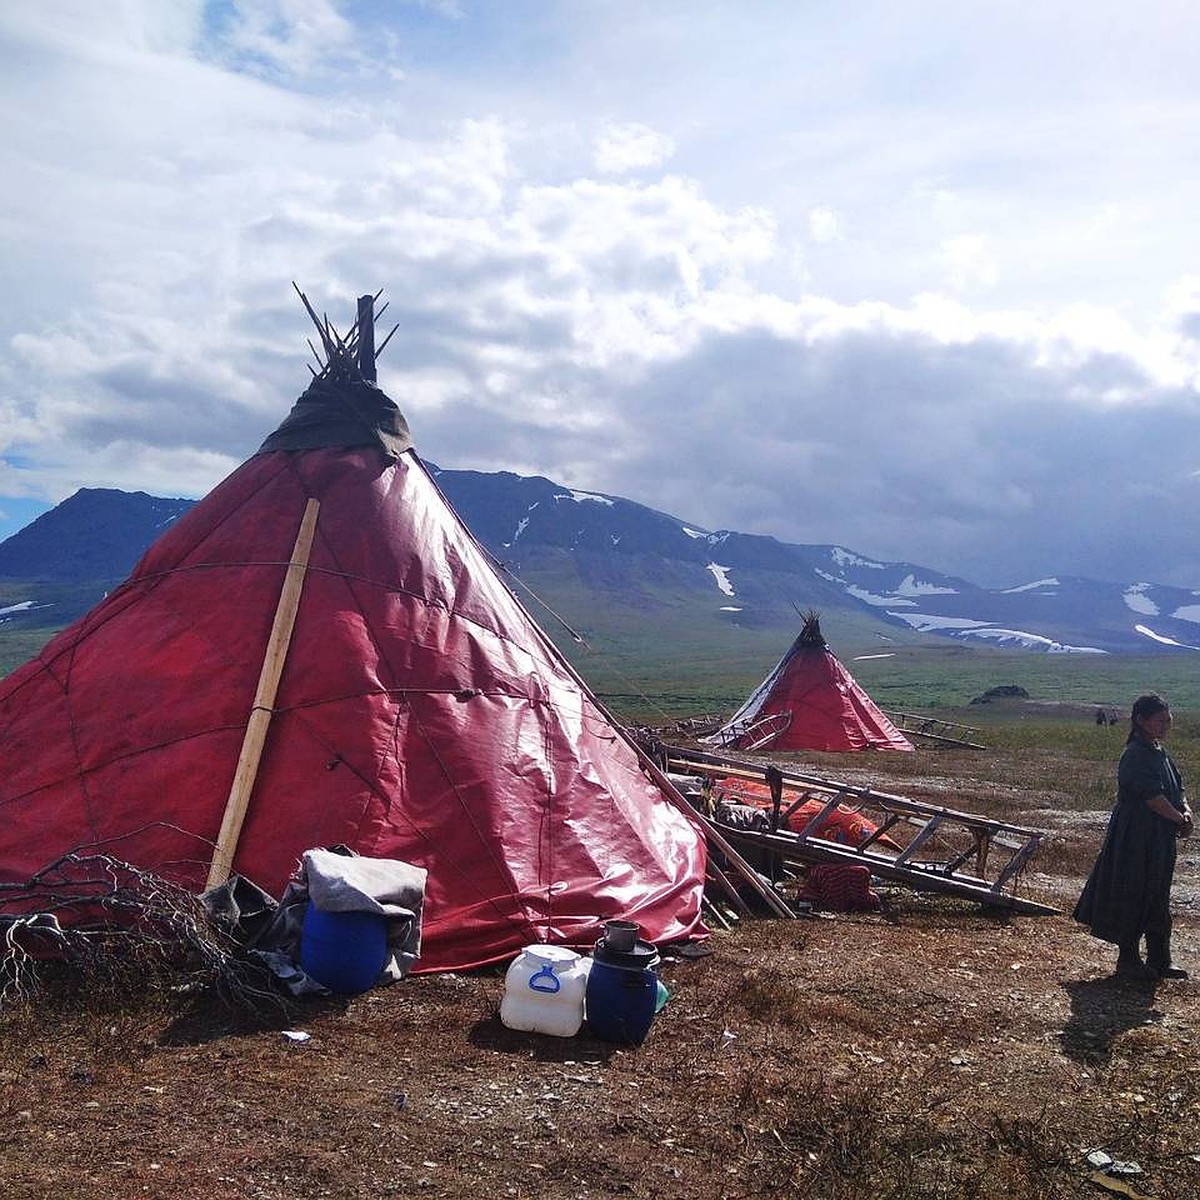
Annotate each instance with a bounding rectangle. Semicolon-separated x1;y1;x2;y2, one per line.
0;0;1200;588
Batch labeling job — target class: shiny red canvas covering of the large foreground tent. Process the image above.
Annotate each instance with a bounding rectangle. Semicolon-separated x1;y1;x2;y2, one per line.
0;369;704;971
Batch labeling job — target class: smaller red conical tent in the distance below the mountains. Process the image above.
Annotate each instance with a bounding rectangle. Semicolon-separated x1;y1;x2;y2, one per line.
709;612;912;750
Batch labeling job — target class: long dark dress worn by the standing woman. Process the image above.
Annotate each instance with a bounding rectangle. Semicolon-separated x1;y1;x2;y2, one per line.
1074;737;1184;947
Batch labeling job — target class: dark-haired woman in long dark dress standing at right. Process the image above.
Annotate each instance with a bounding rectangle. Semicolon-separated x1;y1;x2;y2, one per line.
1074;695;1192;982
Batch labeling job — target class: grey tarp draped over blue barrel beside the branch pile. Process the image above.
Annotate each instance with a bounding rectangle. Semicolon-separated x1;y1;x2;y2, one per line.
200;847;426;995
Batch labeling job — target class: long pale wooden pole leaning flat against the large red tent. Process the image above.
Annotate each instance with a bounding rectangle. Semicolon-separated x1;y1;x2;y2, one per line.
204;498;320;890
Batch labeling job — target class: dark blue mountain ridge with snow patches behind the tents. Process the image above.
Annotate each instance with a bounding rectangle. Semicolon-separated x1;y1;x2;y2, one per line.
0;464;1200;654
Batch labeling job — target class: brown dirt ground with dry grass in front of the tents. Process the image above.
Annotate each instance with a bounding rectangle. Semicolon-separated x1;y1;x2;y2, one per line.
0;729;1200;1200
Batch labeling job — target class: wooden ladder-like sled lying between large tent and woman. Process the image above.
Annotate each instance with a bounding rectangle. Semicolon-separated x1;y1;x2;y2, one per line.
664;746;1058;917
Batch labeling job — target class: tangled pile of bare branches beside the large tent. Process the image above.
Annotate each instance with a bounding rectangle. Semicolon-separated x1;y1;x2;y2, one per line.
0;851;287;1015
